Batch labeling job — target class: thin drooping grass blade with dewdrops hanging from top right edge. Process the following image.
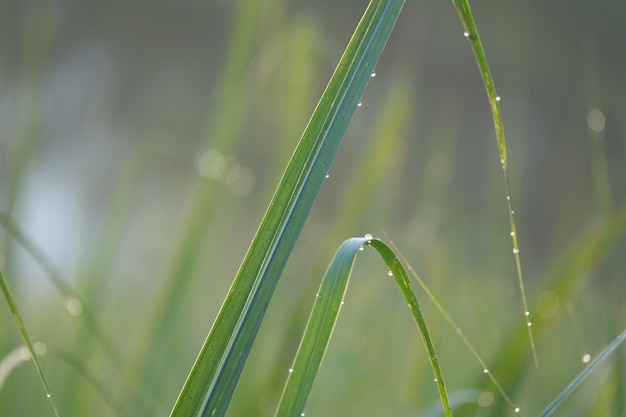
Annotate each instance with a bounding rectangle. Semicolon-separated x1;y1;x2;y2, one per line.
453;0;539;366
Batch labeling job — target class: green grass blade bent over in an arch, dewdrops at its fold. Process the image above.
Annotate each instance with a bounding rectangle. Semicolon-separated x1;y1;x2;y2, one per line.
276;236;452;417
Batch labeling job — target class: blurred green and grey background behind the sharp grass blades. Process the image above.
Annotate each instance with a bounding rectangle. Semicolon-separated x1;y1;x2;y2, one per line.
0;0;626;416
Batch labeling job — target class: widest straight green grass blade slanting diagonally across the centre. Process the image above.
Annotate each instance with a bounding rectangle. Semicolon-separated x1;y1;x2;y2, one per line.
171;0;404;417
